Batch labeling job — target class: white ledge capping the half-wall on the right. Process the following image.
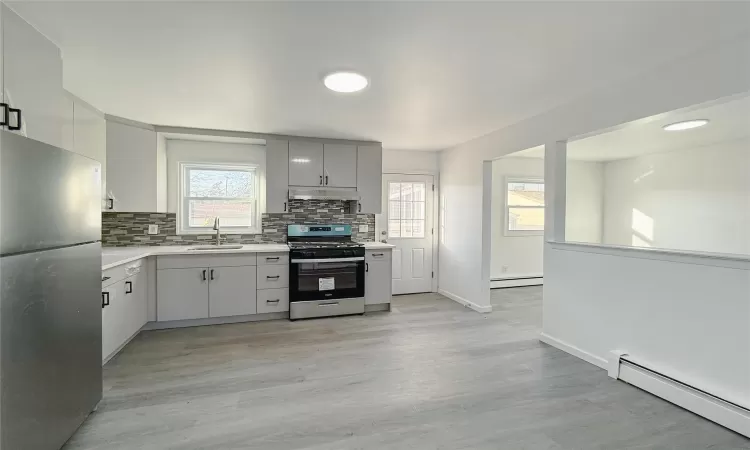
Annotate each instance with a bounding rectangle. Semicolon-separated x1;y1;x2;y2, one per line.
547;240;750;270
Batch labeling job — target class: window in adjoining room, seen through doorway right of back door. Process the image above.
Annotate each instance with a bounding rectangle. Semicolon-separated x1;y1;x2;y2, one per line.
505;178;544;236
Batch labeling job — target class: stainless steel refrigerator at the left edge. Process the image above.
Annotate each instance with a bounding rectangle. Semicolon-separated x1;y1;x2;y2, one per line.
0;130;102;450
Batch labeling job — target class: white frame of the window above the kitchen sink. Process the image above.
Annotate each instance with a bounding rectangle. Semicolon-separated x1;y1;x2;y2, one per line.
177;161;262;234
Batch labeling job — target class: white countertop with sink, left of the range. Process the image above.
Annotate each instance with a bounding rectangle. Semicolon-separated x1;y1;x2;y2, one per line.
102;244;289;270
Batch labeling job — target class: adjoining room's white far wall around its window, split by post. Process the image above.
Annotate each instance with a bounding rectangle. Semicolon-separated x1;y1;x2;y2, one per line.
490;157;604;279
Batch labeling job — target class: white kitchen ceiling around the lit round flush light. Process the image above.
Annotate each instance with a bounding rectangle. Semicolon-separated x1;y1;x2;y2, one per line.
10;1;750;150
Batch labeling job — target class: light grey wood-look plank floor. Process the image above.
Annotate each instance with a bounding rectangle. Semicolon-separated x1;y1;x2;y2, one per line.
65;287;750;450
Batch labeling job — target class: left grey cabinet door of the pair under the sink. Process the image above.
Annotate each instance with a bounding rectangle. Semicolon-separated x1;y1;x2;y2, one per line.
156;268;208;322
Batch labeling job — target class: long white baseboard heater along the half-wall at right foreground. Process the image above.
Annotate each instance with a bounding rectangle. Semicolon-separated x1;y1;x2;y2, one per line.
608;352;750;437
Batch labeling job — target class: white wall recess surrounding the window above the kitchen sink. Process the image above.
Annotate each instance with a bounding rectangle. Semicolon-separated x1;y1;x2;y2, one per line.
166;139;266;213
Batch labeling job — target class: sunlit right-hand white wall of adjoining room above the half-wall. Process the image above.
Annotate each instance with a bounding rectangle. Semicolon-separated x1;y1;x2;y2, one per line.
604;139;750;255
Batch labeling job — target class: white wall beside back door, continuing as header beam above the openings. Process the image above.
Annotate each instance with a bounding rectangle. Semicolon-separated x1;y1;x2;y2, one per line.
439;37;750;307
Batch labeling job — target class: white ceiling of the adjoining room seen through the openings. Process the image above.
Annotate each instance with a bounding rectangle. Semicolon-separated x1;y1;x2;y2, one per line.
510;93;750;161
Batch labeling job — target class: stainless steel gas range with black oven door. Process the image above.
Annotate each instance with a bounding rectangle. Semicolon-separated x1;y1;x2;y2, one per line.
287;225;365;320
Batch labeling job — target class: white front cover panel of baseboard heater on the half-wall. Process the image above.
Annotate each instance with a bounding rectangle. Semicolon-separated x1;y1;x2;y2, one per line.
619;364;750;437
